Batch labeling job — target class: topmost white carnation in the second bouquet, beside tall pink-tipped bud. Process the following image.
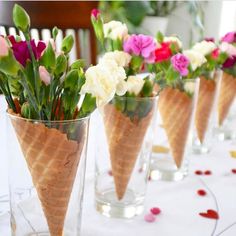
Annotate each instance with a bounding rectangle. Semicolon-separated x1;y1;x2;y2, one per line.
103;20;128;40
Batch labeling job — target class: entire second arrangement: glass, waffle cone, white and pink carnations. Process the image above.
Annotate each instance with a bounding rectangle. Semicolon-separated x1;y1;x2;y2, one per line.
91;11;157;218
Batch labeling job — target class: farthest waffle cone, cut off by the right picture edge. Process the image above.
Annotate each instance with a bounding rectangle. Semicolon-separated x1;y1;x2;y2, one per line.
218;72;236;126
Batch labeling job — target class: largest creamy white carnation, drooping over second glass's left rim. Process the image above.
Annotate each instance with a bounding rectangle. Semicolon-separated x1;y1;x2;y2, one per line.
81;60;127;107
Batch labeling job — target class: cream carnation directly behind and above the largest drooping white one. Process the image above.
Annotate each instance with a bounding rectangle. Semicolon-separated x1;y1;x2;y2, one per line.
101;50;131;67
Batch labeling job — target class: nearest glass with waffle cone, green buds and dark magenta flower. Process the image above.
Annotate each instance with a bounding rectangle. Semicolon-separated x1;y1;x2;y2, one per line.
0;4;113;236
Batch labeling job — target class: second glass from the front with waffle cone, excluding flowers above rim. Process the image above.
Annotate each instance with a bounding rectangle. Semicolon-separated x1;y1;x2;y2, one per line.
95;97;157;218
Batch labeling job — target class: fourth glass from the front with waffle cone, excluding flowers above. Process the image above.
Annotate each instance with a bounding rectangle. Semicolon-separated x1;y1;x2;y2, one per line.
192;70;222;154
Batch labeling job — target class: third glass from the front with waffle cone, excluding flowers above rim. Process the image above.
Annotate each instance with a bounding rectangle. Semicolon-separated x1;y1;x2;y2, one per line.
150;79;199;181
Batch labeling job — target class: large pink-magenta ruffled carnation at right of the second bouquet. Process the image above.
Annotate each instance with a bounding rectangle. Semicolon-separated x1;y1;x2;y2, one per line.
123;34;157;62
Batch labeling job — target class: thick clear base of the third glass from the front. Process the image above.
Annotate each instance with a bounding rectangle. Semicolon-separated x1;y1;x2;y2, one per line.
149;159;188;181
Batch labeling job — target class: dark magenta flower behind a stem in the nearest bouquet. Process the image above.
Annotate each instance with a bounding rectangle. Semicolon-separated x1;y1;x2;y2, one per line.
9;36;46;66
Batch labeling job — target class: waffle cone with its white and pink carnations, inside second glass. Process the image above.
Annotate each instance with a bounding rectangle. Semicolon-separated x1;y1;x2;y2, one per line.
90;10;157;200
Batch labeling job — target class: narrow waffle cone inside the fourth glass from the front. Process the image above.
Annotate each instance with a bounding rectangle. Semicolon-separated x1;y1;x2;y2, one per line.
195;76;216;143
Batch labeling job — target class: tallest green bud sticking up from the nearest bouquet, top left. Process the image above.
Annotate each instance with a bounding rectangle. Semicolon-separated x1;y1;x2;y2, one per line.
13;4;30;33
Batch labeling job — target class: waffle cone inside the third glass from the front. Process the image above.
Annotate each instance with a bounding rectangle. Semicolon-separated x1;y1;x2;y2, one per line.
158;88;193;168
